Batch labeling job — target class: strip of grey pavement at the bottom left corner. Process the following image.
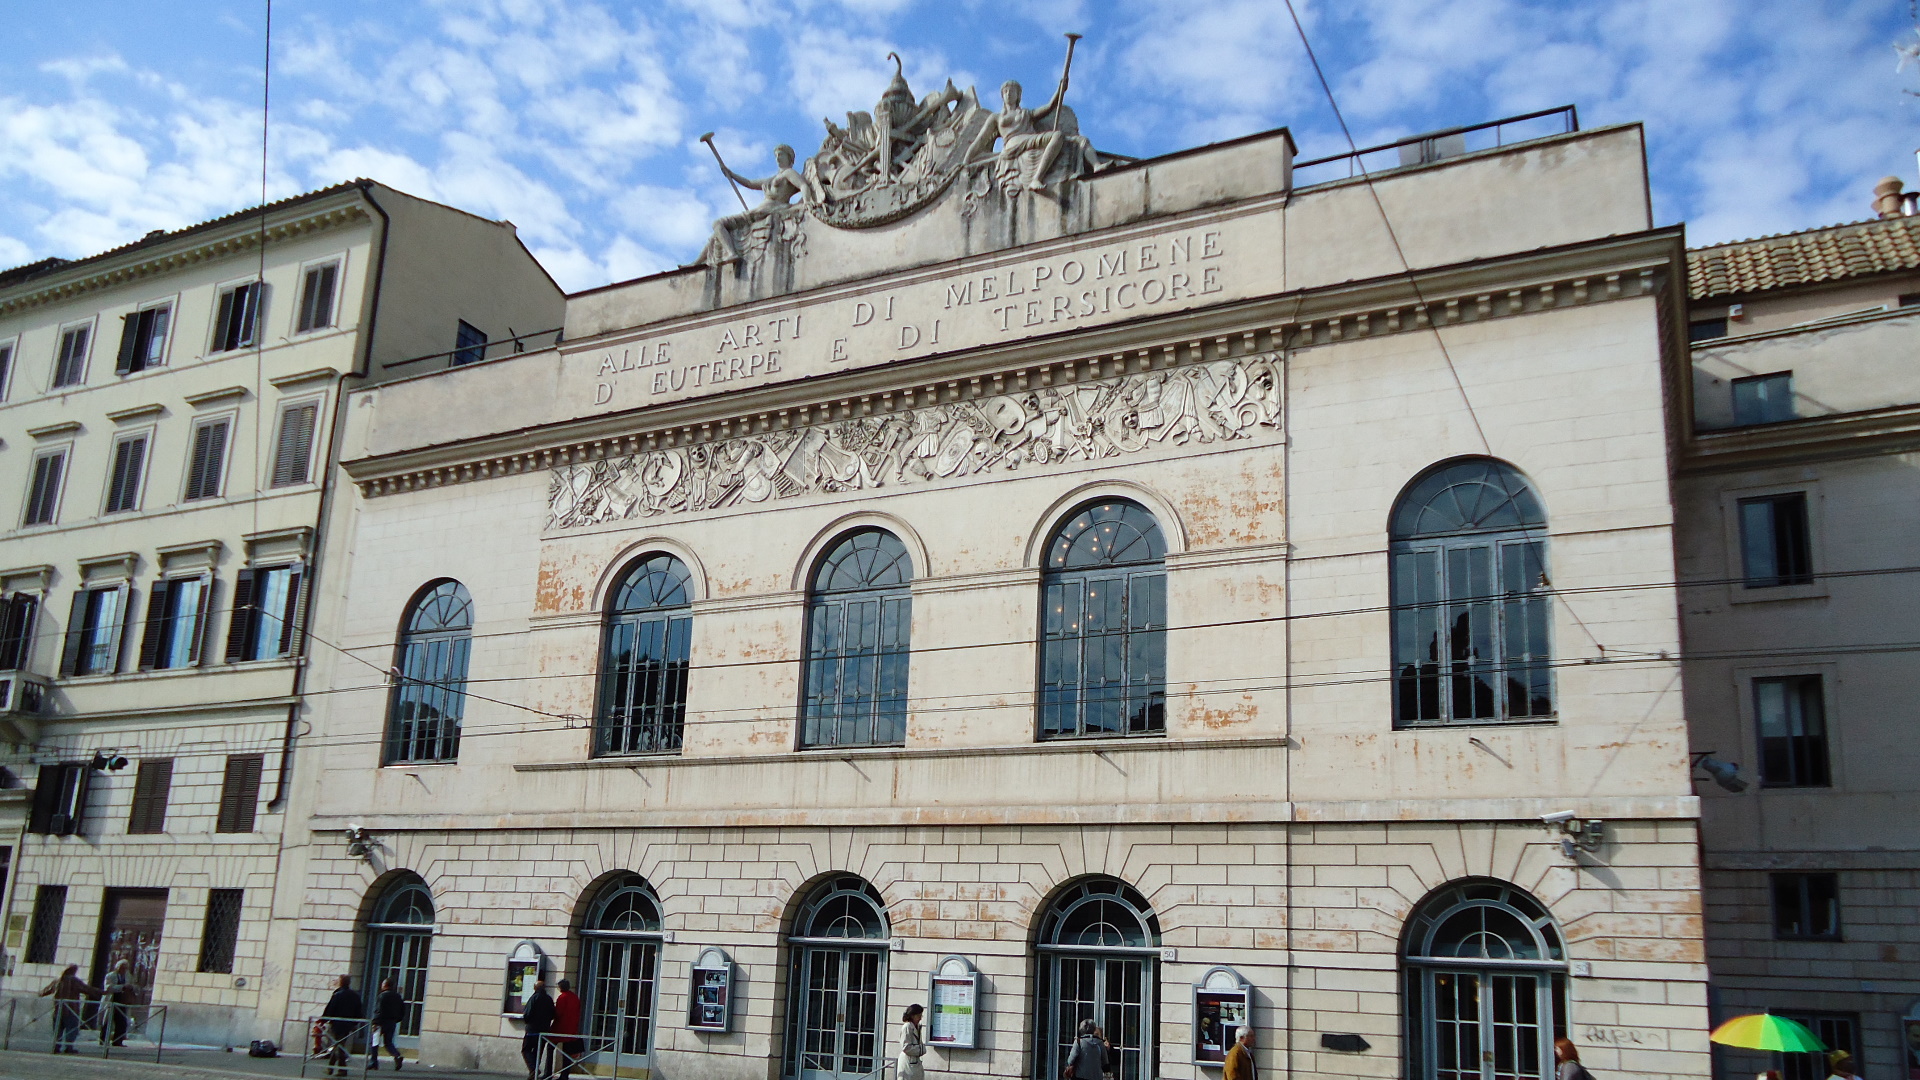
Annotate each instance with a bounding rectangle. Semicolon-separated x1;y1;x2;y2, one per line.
0;1040;524;1080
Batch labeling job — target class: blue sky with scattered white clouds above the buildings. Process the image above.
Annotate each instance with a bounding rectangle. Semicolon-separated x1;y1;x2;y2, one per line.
0;0;1920;288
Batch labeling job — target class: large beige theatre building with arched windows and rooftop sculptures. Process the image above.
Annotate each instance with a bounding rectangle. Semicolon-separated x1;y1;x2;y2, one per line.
295;83;1709;1080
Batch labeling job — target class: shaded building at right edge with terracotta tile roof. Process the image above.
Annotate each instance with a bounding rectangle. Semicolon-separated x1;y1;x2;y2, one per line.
1674;195;1920;1080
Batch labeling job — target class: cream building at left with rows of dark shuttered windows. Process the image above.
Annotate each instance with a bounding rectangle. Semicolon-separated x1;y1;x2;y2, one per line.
0;181;563;1045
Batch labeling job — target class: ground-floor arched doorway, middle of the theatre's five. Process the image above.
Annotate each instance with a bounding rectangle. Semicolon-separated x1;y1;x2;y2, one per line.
787;874;889;1080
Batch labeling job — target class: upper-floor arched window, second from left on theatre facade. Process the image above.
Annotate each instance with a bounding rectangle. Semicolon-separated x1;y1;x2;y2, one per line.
593;553;693;753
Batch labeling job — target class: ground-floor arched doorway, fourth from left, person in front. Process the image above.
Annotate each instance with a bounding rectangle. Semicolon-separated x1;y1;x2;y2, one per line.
1035;878;1160;1080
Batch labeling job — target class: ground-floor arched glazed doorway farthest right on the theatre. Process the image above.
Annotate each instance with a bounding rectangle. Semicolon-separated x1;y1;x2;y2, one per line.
1404;878;1567;1080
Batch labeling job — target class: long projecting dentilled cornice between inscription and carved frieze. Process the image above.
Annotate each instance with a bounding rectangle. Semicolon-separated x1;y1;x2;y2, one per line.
342;229;1684;498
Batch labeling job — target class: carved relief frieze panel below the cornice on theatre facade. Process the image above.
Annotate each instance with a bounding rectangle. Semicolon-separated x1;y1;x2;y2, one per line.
547;354;1281;528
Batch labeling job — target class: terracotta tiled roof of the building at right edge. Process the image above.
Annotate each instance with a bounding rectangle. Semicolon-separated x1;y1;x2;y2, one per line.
1686;217;1920;300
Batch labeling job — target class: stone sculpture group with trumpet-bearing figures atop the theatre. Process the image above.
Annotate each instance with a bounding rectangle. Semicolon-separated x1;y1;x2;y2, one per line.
701;35;1102;265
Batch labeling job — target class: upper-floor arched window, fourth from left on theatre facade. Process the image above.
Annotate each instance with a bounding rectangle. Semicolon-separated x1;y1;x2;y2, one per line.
1041;500;1167;738
